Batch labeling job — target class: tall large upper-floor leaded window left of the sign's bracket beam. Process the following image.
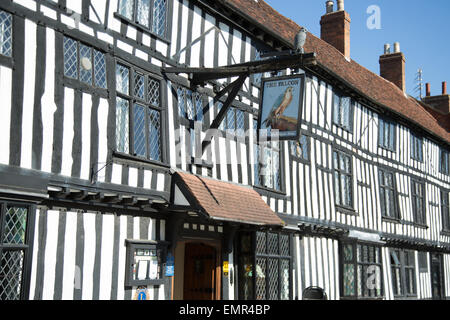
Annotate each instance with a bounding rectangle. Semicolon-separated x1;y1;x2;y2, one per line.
116;63;162;161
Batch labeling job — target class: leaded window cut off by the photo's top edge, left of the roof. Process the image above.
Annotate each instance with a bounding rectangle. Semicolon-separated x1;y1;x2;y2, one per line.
118;0;167;38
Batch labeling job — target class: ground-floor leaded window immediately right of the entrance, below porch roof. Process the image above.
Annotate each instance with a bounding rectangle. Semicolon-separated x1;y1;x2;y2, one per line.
238;231;292;300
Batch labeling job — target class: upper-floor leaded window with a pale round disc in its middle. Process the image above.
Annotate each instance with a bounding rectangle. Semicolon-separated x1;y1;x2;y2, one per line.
64;37;107;89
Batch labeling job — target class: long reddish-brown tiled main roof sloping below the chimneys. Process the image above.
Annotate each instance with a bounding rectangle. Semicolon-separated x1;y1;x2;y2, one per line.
222;0;450;143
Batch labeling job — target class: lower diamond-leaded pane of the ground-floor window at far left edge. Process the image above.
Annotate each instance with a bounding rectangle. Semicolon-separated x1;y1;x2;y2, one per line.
0;249;25;301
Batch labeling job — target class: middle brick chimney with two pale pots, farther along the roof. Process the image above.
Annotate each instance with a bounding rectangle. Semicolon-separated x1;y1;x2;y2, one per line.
380;42;406;92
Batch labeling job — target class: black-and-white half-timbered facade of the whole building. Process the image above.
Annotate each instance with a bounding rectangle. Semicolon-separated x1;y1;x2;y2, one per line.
0;0;450;300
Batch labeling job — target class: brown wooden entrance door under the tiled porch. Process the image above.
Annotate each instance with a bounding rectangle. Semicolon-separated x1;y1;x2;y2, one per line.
183;243;217;300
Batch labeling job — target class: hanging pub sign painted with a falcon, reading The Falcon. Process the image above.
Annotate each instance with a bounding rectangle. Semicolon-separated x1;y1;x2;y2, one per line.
259;75;304;140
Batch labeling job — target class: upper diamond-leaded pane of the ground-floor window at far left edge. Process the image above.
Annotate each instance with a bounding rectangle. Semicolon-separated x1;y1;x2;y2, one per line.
2;207;28;244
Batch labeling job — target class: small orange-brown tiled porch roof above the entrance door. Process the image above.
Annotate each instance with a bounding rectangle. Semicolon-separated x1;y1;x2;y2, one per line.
175;172;284;226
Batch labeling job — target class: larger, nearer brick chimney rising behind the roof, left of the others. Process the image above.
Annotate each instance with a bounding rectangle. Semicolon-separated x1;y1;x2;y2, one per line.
320;0;351;59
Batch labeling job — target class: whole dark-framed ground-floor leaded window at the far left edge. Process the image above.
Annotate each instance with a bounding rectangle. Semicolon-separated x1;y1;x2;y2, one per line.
0;202;31;300
